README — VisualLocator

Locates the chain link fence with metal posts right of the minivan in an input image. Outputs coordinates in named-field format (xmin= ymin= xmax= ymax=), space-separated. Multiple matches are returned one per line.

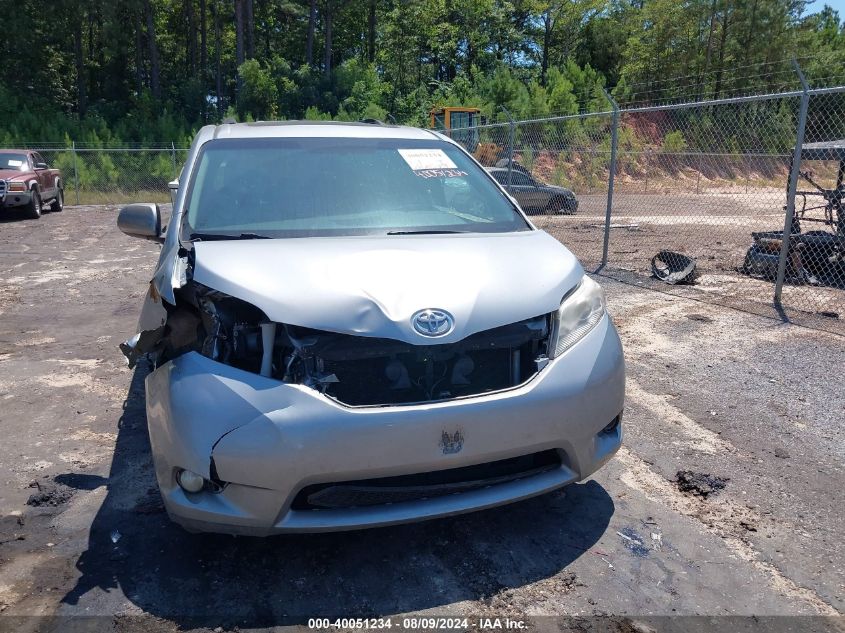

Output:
xmin=450 ymin=87 xmax=845 ymax=334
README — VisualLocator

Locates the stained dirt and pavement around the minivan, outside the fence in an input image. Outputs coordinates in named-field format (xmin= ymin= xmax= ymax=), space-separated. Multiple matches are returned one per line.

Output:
xmin=0 ymin=207 xmax=845 ymax=633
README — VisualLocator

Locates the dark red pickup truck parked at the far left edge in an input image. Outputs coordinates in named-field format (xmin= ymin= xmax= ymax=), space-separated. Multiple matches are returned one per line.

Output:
xmin=0 ymin=149 xmax=64 ymax=218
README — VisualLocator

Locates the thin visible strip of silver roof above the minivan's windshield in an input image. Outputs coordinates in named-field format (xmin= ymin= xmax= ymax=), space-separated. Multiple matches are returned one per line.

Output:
xmin=198 ymin=121 xmax=446 ymax=141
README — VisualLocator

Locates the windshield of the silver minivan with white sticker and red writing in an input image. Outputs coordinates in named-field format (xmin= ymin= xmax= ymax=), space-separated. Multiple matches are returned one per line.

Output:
xmin=182 ymin=138 xmax=530 ymax=239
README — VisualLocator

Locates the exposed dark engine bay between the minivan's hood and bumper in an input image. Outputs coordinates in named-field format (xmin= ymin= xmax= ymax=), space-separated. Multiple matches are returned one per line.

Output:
xmin=127 ymin=281 xmax=553 ymax=406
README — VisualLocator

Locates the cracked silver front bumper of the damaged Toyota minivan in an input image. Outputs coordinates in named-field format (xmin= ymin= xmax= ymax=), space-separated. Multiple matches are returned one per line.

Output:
xmin=146 ymin=317 xmax=625 ymax=535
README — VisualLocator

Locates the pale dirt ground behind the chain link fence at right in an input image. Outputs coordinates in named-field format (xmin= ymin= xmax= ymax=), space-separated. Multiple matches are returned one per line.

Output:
xmin=532 ymin=190 xmax=845 ymax=333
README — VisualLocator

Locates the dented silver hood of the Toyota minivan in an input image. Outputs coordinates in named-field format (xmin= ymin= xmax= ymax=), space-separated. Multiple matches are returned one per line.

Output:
xmin=193 ymin=231 xmax=583 ymax=344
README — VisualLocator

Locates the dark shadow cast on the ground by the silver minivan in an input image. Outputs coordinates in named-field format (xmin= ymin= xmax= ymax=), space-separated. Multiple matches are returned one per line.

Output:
xmin=62 ymin=362 xmax=614 ymax=628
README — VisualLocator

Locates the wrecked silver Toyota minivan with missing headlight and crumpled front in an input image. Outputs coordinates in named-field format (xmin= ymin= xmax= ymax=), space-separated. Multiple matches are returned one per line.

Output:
xmin=118 ymin=122 xmax=625 ymax=535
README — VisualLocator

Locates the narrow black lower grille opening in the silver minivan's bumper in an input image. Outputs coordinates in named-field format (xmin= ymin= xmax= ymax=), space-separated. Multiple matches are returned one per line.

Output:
xmin=291 ymin=450 xmax=561 ymax=510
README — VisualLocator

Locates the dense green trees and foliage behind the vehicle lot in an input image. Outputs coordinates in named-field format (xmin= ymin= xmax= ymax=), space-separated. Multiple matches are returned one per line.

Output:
xmin=0 ymin=0 xmax=845 ymax=170
